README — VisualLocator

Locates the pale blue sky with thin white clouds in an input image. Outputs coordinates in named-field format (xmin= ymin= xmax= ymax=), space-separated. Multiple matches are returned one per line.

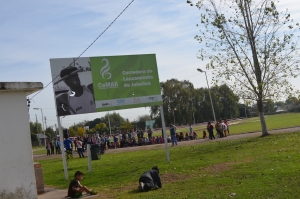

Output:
xmin=0 ymin=0 xmax=300 ymax=127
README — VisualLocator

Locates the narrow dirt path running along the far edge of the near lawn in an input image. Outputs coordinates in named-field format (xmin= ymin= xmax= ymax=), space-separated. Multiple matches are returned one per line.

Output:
xmin=33 ymin=126 xmax=300 ymax=161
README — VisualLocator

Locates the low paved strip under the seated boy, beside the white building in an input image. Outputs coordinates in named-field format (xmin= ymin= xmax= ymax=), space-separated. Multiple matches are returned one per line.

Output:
xmin=38 ymin=188 xmax=99 ymax=199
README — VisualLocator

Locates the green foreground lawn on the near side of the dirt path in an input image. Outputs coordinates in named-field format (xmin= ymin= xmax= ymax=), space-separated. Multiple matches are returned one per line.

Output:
xmin=40 ymin=132 xmax=300 ymax=199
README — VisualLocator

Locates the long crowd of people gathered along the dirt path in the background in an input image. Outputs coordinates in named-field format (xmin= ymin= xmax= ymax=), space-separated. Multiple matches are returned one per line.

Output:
xmin=46 ymin=119 xmax=229 ymax=158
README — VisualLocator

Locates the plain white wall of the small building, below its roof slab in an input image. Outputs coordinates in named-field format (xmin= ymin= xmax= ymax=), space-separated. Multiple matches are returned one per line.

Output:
xmin=0 ymin=82 xmax=41 ymax=199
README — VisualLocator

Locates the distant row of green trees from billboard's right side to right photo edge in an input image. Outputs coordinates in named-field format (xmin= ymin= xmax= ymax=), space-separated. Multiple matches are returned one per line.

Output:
xmin=150 ymin=79 xmax=300 ymax=127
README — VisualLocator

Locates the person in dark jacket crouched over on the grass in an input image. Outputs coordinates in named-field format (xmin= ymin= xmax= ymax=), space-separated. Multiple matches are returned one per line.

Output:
xmin=139 ymin=166 xmax=162 ymax=191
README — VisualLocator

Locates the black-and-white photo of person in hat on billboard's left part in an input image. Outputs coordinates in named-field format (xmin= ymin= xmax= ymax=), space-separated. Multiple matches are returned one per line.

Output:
xmin=50 ymin=57 xmax=96 ymax=116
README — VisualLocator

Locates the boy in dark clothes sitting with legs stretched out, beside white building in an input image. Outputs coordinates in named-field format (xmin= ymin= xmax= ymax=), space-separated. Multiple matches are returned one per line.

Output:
xmin=65 ymin=171 xmax=97 ymax=198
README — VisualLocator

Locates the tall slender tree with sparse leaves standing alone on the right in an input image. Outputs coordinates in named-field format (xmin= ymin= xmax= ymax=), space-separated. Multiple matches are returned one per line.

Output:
xmin=195 ymin=0 xmax=299 ymax=135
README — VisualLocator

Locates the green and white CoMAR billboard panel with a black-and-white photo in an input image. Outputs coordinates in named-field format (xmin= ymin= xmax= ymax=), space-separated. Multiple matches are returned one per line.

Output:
xmin=50 ymin=54 xmax=162 ymax=116
